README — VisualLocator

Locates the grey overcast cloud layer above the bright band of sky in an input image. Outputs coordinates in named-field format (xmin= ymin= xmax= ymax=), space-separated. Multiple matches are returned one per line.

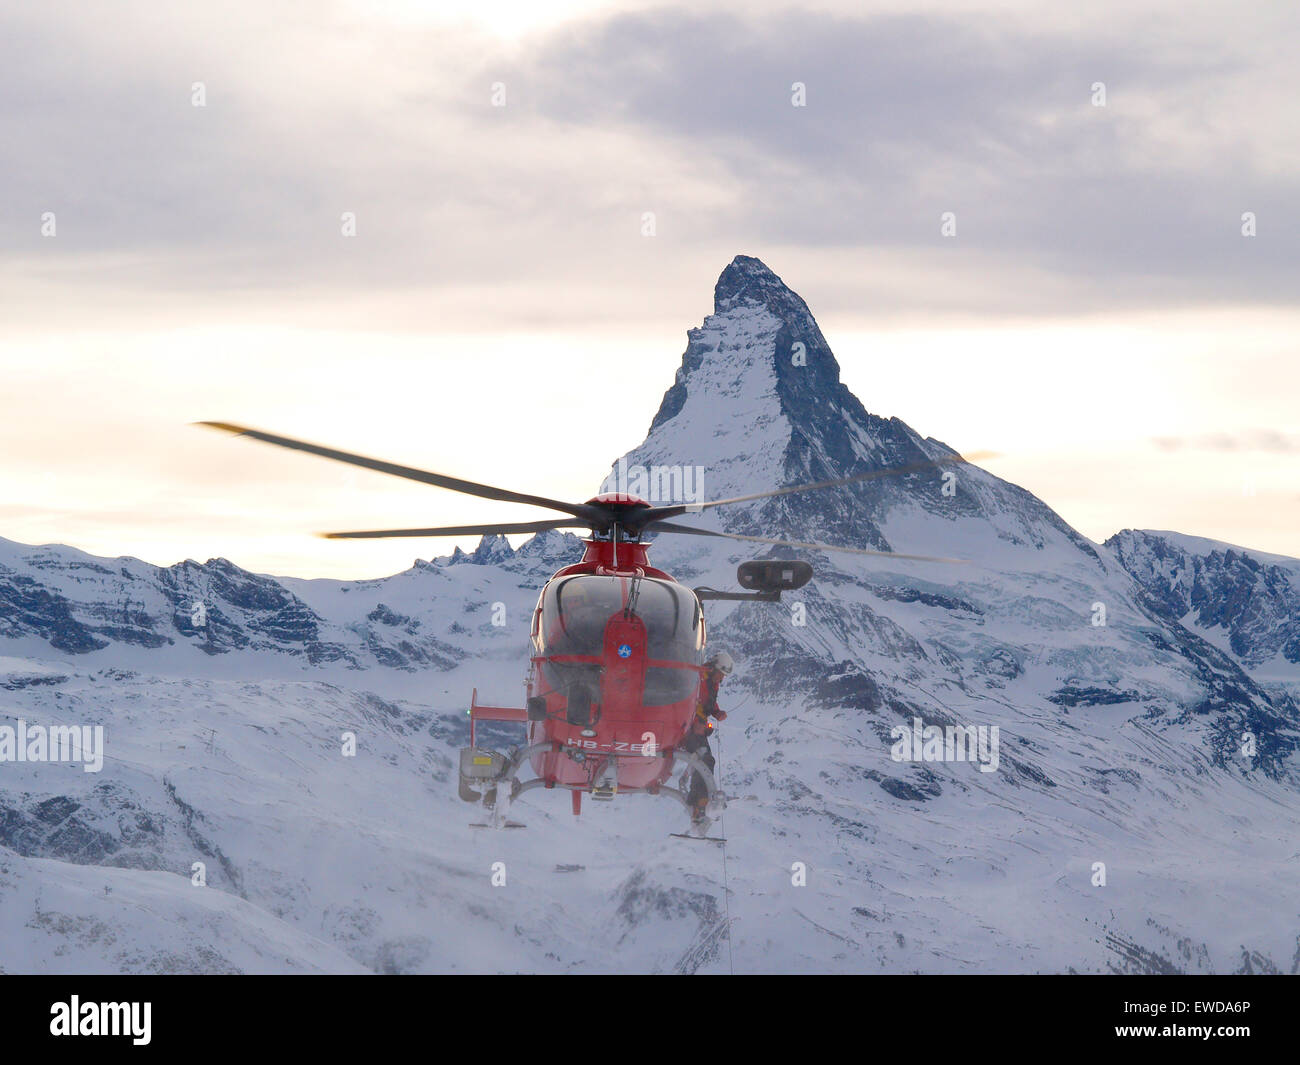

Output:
xmin=0 ymin=4 xmax=1300 ymax=325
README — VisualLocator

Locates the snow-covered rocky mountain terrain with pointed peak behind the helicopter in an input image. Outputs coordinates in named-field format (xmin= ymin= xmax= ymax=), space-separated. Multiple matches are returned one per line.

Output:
xmin=0 ymin=256 xmax=1300 ymax=971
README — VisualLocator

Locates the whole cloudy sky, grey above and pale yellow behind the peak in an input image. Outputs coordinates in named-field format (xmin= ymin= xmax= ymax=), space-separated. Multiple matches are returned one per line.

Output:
xmin=0 ymin=0 xmax=1300 ymax=576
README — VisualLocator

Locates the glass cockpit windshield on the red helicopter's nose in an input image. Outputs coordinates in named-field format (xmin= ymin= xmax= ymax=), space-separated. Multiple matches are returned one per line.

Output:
xmin=533 ymin=573 xmax=705 ymax=706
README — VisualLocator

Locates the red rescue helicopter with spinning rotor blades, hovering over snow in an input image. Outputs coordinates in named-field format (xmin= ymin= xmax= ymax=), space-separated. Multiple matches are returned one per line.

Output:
xmin=199 ymin=421 xmax=967 ymax=835
